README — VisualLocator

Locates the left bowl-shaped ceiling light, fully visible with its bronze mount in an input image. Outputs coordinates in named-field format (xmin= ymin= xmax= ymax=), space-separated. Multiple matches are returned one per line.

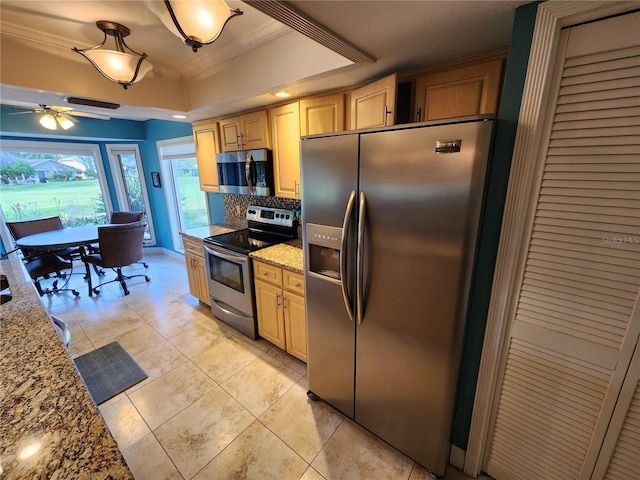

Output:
xmin=72 ymin=20 xmax=153 ymax=90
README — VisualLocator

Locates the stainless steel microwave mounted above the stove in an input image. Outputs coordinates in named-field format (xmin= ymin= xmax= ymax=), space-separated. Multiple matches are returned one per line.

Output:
xmin=216 ymin=149 xmax=274 ymax=196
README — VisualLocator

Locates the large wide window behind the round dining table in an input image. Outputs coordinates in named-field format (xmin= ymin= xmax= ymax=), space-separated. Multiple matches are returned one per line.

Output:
xmin=0 ymin=140 xmax=112 ymax=246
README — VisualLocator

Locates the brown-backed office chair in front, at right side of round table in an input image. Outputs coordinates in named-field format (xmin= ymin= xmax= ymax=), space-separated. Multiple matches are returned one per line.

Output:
xmin=83 ymin=221 xmax=151 ymax=296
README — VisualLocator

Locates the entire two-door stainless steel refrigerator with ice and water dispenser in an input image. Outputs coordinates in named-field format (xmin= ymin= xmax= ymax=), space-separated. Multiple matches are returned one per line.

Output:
xmin=300 ymin=117 xmax=493 ymax=475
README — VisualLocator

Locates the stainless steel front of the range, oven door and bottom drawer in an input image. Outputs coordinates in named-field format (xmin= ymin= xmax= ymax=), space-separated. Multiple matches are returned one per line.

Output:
xmin=204 ymin=243 xmax=257 ymax=338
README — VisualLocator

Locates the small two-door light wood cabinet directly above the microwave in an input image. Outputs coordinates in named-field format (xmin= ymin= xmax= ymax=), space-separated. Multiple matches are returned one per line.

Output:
xmin=220 ymin=110 xmax=271 ymax=152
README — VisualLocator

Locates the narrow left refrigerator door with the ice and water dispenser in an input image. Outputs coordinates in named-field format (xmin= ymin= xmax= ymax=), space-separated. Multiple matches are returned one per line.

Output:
xmin=300 ymin=134 xmax=359 ymax=418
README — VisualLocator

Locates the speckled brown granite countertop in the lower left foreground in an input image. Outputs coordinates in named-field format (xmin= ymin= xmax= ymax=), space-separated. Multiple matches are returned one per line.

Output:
xmin=0 ymin=255 xmax=133 ymax=480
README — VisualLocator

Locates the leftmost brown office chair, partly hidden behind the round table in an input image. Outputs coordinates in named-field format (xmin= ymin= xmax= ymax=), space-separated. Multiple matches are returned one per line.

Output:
xmin=6 ymin=216 xmax=80 ymax=297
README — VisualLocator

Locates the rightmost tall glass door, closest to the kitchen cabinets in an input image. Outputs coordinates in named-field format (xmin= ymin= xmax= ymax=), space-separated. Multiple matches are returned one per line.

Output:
xmin=157 ymin=136 xmax=209 ymax=251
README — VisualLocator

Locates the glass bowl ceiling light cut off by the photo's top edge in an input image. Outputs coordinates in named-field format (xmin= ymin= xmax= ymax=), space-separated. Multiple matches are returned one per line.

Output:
xmin=144 ymin=0 xmax=243 ymax=52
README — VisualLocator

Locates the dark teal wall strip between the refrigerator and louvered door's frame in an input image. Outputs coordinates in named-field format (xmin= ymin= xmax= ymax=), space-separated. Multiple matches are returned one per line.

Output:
xmin=451 ymin=2 xmax=540 ymax=450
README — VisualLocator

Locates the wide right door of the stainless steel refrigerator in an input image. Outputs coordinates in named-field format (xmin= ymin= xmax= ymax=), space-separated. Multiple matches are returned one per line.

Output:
xmin=355 ymin=122 xmax=492 ymax=475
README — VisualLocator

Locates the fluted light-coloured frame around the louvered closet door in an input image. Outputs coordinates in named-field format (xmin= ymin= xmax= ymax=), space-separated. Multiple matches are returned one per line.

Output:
xmin=464 ymin=1 xmax=638 ymax=477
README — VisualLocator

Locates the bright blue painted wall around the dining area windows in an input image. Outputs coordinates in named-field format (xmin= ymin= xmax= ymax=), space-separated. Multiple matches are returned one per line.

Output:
xmin=0 ymin=106 xmax=192 ymax=250
